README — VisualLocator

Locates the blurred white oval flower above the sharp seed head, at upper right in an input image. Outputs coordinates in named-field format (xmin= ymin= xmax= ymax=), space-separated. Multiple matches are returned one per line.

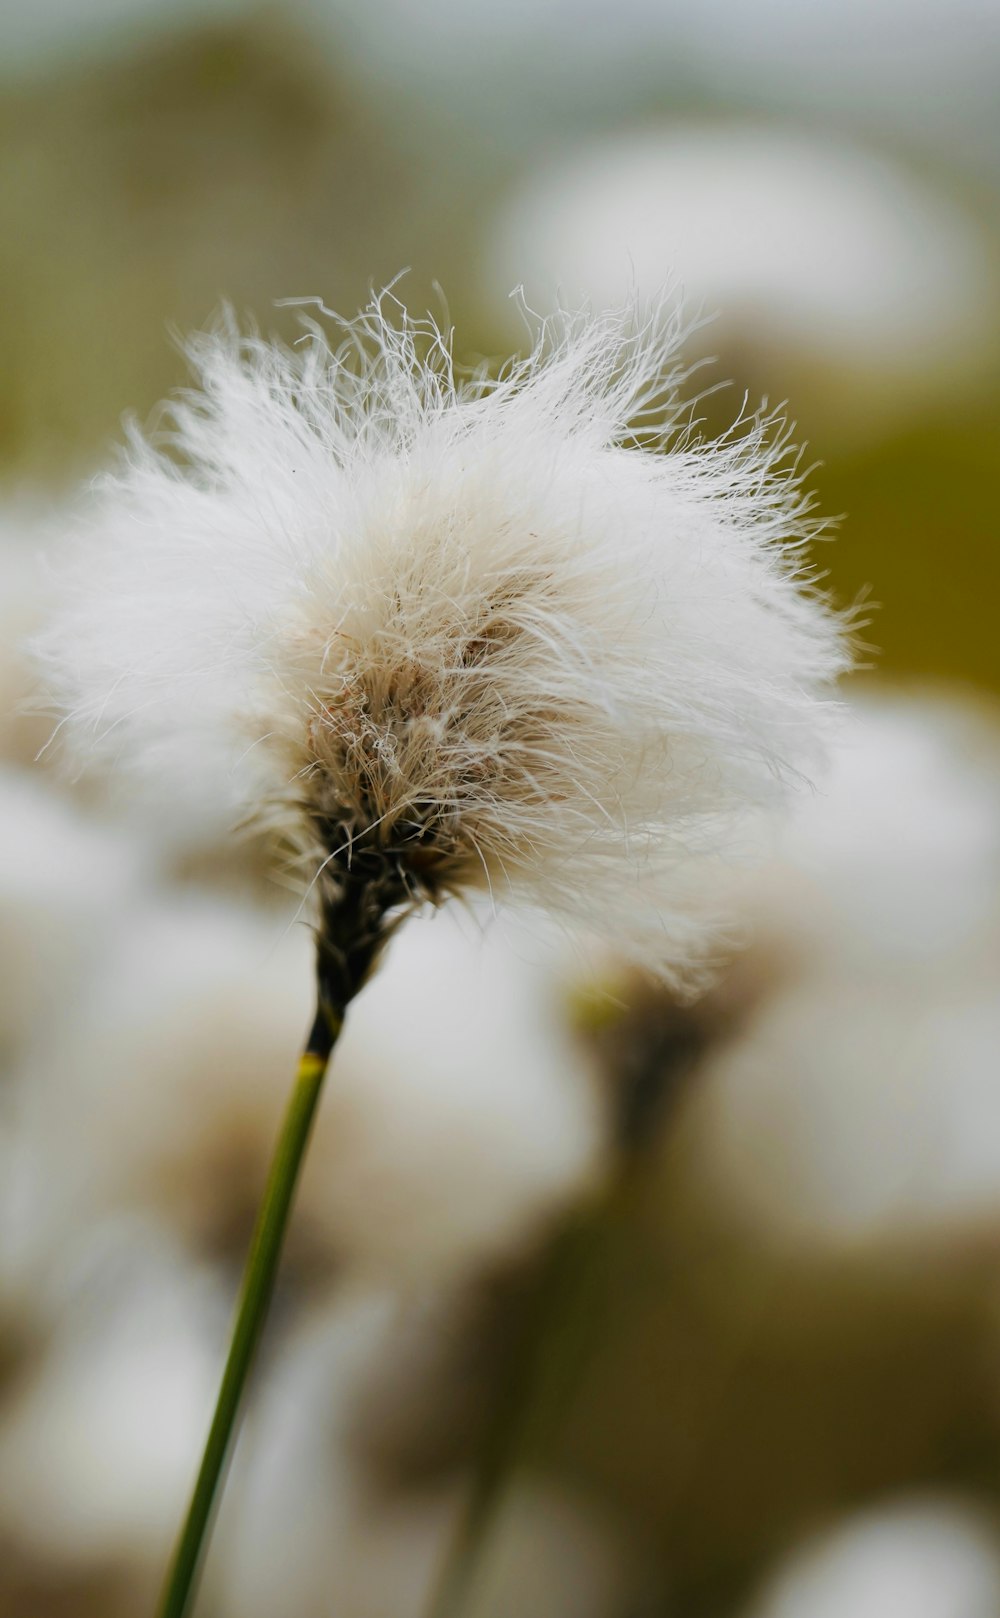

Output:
xmin=481 ymin=123 xmax=997 ymax=424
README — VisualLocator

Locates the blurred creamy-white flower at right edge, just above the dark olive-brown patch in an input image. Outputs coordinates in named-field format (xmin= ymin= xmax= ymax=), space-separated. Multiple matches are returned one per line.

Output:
xmin=688 ymin=972 xmax=1000 ymax=1246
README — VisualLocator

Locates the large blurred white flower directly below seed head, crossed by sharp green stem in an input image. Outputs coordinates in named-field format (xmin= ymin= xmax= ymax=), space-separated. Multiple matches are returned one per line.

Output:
xmin=3 ymin=893 xmax=604 ymax=1301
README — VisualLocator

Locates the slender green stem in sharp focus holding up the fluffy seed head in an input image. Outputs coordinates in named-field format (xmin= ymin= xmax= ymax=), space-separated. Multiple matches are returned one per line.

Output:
xmin=157 ymin=1010 xmax=340 ymax=1618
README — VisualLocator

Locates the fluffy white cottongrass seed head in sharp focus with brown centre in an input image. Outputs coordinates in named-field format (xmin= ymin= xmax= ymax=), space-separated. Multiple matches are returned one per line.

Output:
xmin=42 ymin=294 xmax=846 ymax=979
